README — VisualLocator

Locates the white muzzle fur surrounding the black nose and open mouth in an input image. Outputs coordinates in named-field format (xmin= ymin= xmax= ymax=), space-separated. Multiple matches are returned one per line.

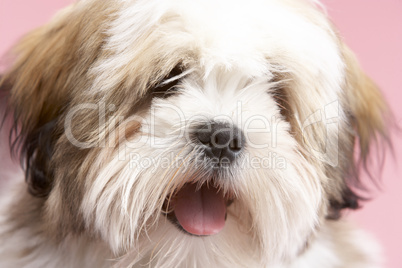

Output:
xmin=82 ymin=72 xmax=321 ymax=265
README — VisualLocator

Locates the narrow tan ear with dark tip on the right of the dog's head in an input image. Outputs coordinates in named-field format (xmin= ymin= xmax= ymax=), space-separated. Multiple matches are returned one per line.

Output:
xmin=329 ymin=44 xmax=390 ymax=218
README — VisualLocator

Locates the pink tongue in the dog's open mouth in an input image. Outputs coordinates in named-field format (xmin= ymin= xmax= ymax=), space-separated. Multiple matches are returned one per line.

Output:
xmin=174 ymin=184 xmax=226 ymax=235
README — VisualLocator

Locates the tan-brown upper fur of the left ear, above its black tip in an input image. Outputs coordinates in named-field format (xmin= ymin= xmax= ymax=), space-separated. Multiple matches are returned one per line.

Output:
xmin=4 ymin=1 xmax=118 ymax=135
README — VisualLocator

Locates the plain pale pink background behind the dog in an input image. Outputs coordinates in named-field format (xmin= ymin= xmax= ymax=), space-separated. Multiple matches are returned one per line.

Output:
xmin=0 ymin=0 xmax=402 ymax=268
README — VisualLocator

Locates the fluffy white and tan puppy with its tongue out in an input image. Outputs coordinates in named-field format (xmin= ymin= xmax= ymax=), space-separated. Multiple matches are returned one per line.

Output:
xmin=0 ymin=0 xmax=387 ymax=268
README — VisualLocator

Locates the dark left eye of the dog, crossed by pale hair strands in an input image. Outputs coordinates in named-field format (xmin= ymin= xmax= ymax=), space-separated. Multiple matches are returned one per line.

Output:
xmin=152 ymin=65 xmax=184 ymax=99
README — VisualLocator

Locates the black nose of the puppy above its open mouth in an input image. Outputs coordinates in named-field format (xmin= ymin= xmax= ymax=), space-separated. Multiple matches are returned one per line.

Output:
xmin=195 ymin=122 xmax=245 ymax=163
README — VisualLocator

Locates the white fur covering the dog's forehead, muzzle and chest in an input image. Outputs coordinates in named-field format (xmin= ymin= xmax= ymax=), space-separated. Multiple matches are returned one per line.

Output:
xmin=0 ymin=0 xmax=384 ymax=268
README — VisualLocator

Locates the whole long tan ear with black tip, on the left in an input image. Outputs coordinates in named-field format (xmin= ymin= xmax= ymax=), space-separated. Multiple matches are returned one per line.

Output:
xmin=0 ymin=3 xmax=107 ymax=196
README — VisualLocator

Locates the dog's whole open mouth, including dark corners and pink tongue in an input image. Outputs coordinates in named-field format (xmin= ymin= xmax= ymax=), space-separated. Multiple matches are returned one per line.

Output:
xmin=163 ymin=183 xmax=233 ymax=236
